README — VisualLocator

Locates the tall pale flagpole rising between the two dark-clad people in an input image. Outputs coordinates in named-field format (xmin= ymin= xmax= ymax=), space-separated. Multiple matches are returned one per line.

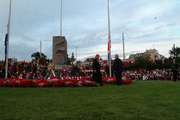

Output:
xmin=107 ymin=0 xmax=111 ymax=76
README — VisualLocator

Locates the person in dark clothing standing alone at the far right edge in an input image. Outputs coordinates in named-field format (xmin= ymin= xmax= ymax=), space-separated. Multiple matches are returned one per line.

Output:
xmin=172 ymin=59 xmax=179 ymax=82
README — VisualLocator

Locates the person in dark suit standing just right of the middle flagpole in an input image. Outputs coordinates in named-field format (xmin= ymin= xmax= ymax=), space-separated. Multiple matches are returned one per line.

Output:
xmin=113 ymin=54 xmax=122 ymax=86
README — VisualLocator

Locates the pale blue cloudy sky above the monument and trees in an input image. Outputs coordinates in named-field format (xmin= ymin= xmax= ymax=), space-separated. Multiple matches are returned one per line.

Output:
xmin=0 ymin=0 xmax=180 ymax=61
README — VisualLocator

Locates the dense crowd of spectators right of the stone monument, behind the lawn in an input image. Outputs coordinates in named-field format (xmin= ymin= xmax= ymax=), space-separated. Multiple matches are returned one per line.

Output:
xmin=84 ymin=59 xmax=180 ymax=81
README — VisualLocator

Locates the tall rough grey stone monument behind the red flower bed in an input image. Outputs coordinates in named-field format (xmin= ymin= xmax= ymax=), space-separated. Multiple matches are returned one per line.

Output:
xmin=52 ymin=36 xmax=69 ymax=77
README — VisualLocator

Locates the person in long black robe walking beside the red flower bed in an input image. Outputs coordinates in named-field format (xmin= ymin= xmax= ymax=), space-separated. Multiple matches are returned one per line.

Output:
xmin=91 ymin=54 xmax=103 ymax=86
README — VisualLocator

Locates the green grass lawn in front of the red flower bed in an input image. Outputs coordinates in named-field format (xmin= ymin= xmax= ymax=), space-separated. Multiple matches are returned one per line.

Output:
xmin=0 ymin=81 xmax=180 ymax=120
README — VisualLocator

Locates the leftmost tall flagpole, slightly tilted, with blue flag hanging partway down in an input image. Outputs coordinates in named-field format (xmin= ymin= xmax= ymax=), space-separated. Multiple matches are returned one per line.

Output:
xmin=5 ymin=0 xmax=12 ymax=78
